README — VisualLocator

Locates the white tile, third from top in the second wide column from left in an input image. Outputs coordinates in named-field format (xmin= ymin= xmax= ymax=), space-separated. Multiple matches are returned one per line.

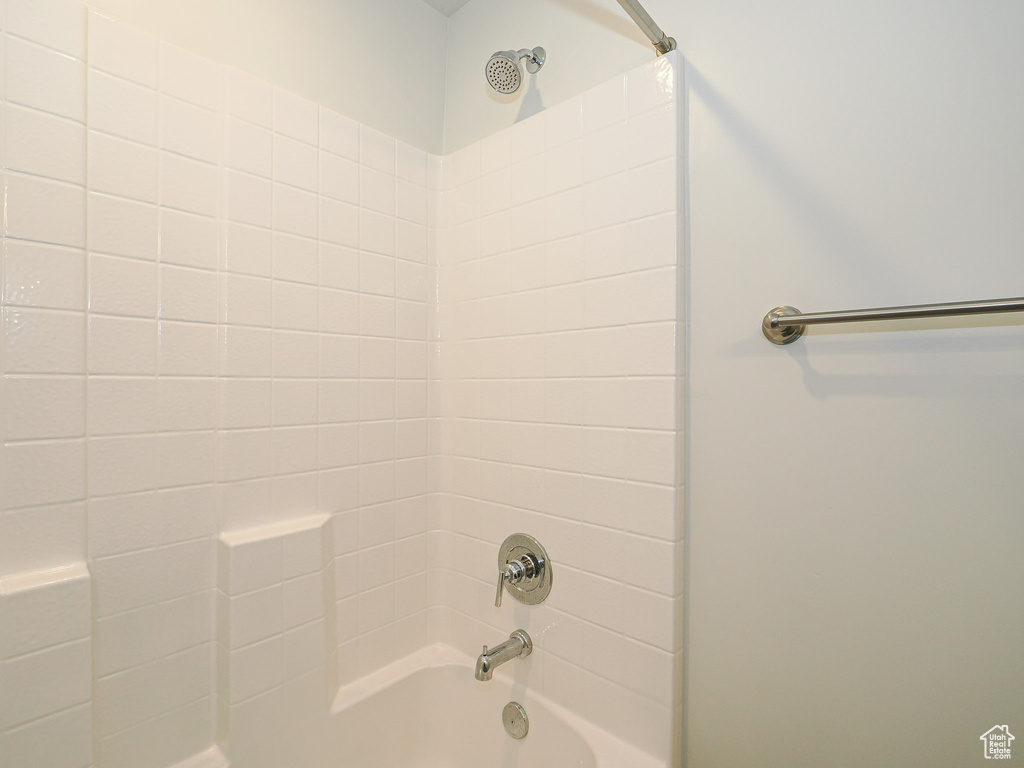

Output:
xmin=89 ymin=132 xmax=160 ymax=203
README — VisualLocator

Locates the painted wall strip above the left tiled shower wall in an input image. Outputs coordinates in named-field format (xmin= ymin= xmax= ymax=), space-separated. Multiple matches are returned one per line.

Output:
xmin=89 ymin=0 xmax=447 ymax=153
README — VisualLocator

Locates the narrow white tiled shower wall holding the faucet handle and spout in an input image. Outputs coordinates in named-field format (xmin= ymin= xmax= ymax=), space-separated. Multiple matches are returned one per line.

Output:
xmin=430 ymin=54 xmax=684 ymax=760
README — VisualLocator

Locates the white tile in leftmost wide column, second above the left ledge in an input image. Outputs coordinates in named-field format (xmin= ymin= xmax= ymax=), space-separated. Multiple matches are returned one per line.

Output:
xmin=3 ymin=440 xmax=85 ymax=509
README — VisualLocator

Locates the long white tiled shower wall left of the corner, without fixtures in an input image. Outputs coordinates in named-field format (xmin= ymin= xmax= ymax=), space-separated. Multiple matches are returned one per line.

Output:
xmin=0 ymin=0 xmax=428 ymax=768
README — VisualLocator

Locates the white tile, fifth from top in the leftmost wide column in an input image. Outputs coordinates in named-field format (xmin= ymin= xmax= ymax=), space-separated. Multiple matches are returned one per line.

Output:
xmin=3 ymin=240 xmax=85 ymax=309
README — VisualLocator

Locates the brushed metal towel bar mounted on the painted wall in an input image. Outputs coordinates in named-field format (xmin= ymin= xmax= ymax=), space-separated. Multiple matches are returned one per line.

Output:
xmin=761 ymin=298 xmax=1024 ymax=344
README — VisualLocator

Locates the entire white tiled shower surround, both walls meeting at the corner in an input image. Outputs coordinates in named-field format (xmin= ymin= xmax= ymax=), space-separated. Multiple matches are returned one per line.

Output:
xmin=0 ymin=0 xmax=682 ymax=768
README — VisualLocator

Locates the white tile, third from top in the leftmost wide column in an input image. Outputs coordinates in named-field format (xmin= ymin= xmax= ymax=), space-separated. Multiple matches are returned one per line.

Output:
xmin=6 ymin=104 xmax=85 ymax=184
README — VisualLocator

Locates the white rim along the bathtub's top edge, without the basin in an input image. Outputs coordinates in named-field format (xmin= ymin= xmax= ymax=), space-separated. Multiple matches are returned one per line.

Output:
xmin=331 ymin=643 xmax=668 ymax=768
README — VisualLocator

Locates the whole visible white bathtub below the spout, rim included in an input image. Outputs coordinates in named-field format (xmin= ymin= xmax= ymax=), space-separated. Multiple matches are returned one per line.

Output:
xmin=328 ymin=645 xmax=665 ymax=768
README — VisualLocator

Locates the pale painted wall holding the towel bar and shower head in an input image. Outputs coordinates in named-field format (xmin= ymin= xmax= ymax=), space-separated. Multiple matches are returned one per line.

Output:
xmin=445 ymin=0 xmax=1024 ymax=768
